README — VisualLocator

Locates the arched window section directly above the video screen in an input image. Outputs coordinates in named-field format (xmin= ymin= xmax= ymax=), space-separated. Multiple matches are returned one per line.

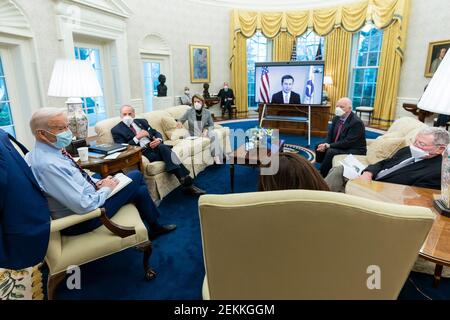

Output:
xmin=296 ymin=30 xmax=325 ymax=61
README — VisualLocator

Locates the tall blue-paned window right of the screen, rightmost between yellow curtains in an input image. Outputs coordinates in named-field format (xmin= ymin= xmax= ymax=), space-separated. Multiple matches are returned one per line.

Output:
xmin=350 ymin=25 xmax=383 ymax=107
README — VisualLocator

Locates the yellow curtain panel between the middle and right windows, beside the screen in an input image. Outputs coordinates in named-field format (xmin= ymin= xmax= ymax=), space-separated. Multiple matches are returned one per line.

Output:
xmin=325 ymin=28 xmax=352 ymax=113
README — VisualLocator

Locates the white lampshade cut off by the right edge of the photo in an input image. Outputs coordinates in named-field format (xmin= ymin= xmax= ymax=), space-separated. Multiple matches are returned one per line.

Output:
xmin=417 ymin=54 xmax=450 ymax=114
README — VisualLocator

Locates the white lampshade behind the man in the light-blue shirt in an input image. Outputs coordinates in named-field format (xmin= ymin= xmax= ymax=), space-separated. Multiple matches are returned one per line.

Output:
xmin=48 ymin=60 xmax=103 ymax=98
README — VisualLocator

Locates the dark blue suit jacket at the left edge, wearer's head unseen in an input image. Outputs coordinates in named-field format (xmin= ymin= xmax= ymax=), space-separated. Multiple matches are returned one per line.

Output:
xmin=0 ymin=129 xmax=50 ymax=270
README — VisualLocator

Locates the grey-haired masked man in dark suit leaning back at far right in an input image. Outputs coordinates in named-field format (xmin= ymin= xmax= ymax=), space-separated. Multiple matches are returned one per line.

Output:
xmin=325 ymin=128 xmax=450 ymax=192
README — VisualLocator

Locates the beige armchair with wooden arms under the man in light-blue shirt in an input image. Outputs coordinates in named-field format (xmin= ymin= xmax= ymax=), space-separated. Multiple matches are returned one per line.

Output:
xmin=45 ymin=204 xmax=156 ymax=300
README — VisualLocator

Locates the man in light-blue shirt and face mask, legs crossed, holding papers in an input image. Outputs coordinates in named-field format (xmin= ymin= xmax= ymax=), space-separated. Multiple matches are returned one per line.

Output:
xmin=25 ymin=108 xmax=176 ymax=239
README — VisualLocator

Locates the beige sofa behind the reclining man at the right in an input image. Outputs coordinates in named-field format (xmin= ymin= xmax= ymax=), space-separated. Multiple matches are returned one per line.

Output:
xmin=333 ymin=117 xmax=427 ymax=167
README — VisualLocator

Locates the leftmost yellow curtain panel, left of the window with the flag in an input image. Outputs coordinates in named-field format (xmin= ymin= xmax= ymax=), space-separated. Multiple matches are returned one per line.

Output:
xmin=231 ymin=33 xmax=248 ymax=118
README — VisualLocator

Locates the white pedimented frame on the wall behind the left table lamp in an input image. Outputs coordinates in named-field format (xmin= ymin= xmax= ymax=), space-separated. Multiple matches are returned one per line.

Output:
xmin=55 ymin=0 xmax=132 ymax=120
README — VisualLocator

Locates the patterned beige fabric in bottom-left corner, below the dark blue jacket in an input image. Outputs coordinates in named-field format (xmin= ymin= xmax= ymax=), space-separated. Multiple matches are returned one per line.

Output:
xmin=0 ymin=266 xmax=44 ymax=300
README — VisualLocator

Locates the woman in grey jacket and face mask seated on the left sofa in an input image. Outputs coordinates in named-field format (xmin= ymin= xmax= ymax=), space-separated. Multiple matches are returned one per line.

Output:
xmin=177 ymin=94 xmax=223 ymax=164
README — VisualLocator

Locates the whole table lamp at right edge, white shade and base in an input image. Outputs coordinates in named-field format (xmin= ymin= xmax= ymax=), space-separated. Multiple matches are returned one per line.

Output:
xmin=417 ymin=54 xmax=450 ymax=216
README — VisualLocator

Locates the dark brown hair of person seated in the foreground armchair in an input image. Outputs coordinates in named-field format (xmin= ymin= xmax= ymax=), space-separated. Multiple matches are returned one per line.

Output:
xmin=259 ymin=153 xmax=330 ymax=191
